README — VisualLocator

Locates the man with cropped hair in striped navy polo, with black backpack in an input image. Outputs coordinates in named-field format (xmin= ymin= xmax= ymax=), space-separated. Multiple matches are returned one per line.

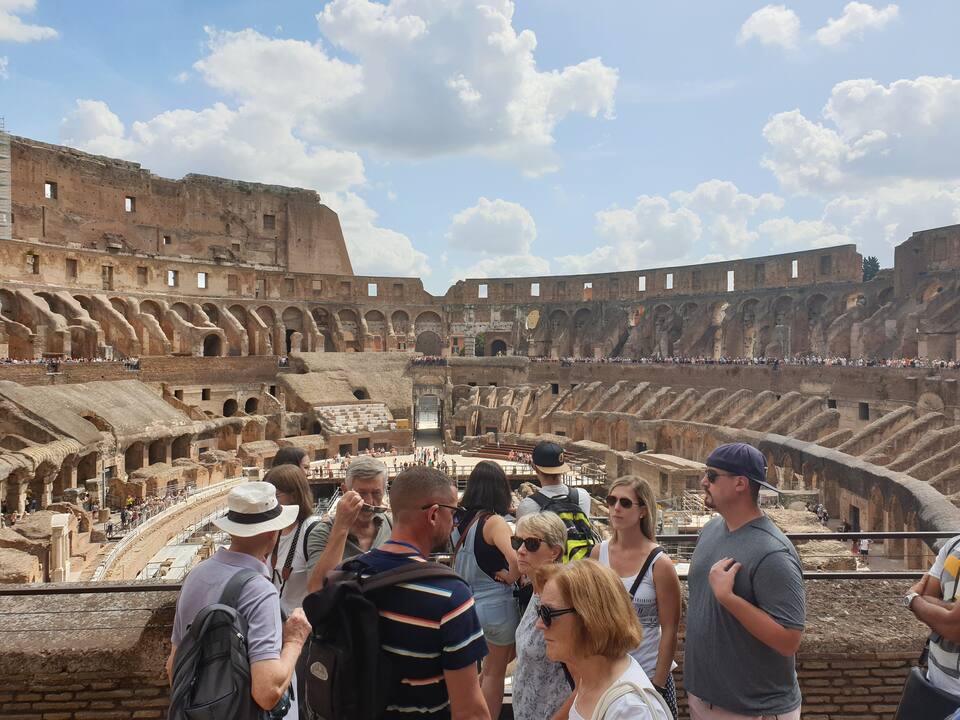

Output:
xmin=304 ymin=466 xmax=489 ymax=720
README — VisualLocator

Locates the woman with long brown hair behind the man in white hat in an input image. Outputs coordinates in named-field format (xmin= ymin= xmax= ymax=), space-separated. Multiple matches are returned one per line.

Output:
xmin=263 ymin=465 xmax=319 ymax=615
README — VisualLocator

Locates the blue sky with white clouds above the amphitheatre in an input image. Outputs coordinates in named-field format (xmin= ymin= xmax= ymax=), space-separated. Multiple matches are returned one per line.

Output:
xmin=0 ymin=0 xmax=960 ymax=294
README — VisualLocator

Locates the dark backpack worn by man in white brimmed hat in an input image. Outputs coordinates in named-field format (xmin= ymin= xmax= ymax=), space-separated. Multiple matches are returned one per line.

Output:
xmin=167 ymin=569 xmax=268 ymax=720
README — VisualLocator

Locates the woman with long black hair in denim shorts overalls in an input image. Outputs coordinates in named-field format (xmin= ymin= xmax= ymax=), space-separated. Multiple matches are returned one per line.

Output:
xmin=453 ymin=460 xmax=520 ymax=718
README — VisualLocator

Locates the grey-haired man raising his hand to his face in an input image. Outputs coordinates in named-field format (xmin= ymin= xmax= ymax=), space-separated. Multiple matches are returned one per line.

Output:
xmin=306 ymin=455 xmax=392 ymax=592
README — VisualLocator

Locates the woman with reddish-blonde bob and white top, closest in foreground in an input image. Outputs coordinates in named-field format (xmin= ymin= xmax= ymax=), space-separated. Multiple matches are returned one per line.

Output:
xmin=535 ymin=560 xmax=671 ymax=720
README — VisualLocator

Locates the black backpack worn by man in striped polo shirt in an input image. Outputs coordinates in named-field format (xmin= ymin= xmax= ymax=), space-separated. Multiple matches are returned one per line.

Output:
xmin=300 ymin=559 xmax=460 ymax=720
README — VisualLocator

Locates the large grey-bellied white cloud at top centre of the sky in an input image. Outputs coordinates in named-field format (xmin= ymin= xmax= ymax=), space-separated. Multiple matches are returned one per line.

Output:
xmin=313 ymin=0 xmax=618 ymax=175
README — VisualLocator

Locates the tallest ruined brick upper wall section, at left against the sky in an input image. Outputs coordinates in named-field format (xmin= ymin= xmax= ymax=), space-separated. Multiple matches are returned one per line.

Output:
xmin=10 ymin=137 xmax=353 ymax=275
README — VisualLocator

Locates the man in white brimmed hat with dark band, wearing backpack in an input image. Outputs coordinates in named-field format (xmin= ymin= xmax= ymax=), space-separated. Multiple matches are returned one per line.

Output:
xmin=167 ymin=482 xmax=310 ymax=720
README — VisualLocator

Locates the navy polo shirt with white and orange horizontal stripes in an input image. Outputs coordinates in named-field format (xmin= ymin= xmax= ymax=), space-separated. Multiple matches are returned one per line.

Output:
xmin=354 ymin=550 xmax=487 ymax=720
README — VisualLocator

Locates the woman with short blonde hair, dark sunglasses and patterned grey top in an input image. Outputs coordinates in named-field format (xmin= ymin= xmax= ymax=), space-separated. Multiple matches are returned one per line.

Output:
xmin=511 ymin=512 xmax=572 ymax=720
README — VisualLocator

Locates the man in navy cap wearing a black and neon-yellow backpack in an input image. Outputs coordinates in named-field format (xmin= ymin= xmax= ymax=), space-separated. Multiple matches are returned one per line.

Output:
xmin=517 ymin=441 xmax=600 ymax=562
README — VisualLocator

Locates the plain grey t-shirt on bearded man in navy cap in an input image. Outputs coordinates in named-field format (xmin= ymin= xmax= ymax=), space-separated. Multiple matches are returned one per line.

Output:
xmin=683 ymin=515 xmax=806 ymax=716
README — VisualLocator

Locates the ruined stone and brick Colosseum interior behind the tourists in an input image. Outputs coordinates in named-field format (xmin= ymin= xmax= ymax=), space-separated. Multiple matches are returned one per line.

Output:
xmin=0 ymin=135 xmax=960 ymax=720
